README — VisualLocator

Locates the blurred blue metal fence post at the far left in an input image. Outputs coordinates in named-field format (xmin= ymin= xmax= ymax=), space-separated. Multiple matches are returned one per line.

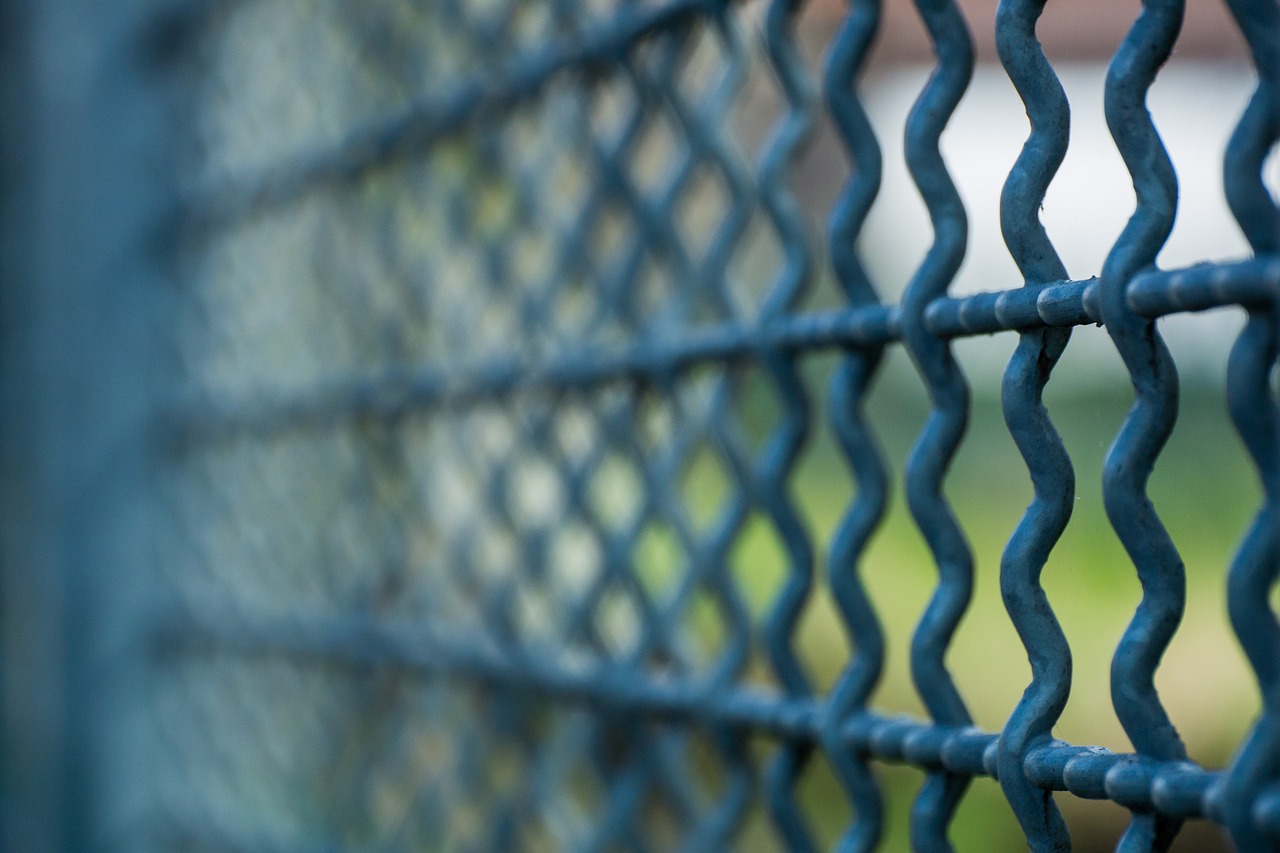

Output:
xmin=0 ymin=0 xmax=172 ymax=853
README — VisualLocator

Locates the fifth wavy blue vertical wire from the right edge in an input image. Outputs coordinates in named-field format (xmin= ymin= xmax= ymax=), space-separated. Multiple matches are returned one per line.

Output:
xmin=823 ymin=0 xmax=888 ymax=853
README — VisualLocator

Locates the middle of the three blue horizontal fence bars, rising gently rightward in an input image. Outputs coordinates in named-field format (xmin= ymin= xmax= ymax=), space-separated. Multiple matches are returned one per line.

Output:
xmin=172 ymin=259 xmax=1280 ymax=447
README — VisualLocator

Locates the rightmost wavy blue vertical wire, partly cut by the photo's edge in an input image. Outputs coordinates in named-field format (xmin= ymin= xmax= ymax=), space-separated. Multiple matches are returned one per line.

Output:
xmin=1219 ymin=0 xmax=1280 ymax=853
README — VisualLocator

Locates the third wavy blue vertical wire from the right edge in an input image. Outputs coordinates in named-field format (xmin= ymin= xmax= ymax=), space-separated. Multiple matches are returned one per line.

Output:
xmin=996 ymin=0 xmax=1075 ymax=853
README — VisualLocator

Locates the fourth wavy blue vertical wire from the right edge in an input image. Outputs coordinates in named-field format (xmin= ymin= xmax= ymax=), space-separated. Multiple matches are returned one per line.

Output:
xmin=902 ymin=0 xmax=973 ymax=853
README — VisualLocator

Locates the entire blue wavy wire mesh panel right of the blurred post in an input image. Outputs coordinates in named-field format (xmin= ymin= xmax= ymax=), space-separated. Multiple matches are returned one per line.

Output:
xmin=146 ymin=0 xmax=1280 ymax=850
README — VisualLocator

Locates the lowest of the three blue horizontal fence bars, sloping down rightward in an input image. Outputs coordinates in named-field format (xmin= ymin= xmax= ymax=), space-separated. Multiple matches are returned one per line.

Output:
xmin=152 ymin=601 xmax=1249 ymax=824
